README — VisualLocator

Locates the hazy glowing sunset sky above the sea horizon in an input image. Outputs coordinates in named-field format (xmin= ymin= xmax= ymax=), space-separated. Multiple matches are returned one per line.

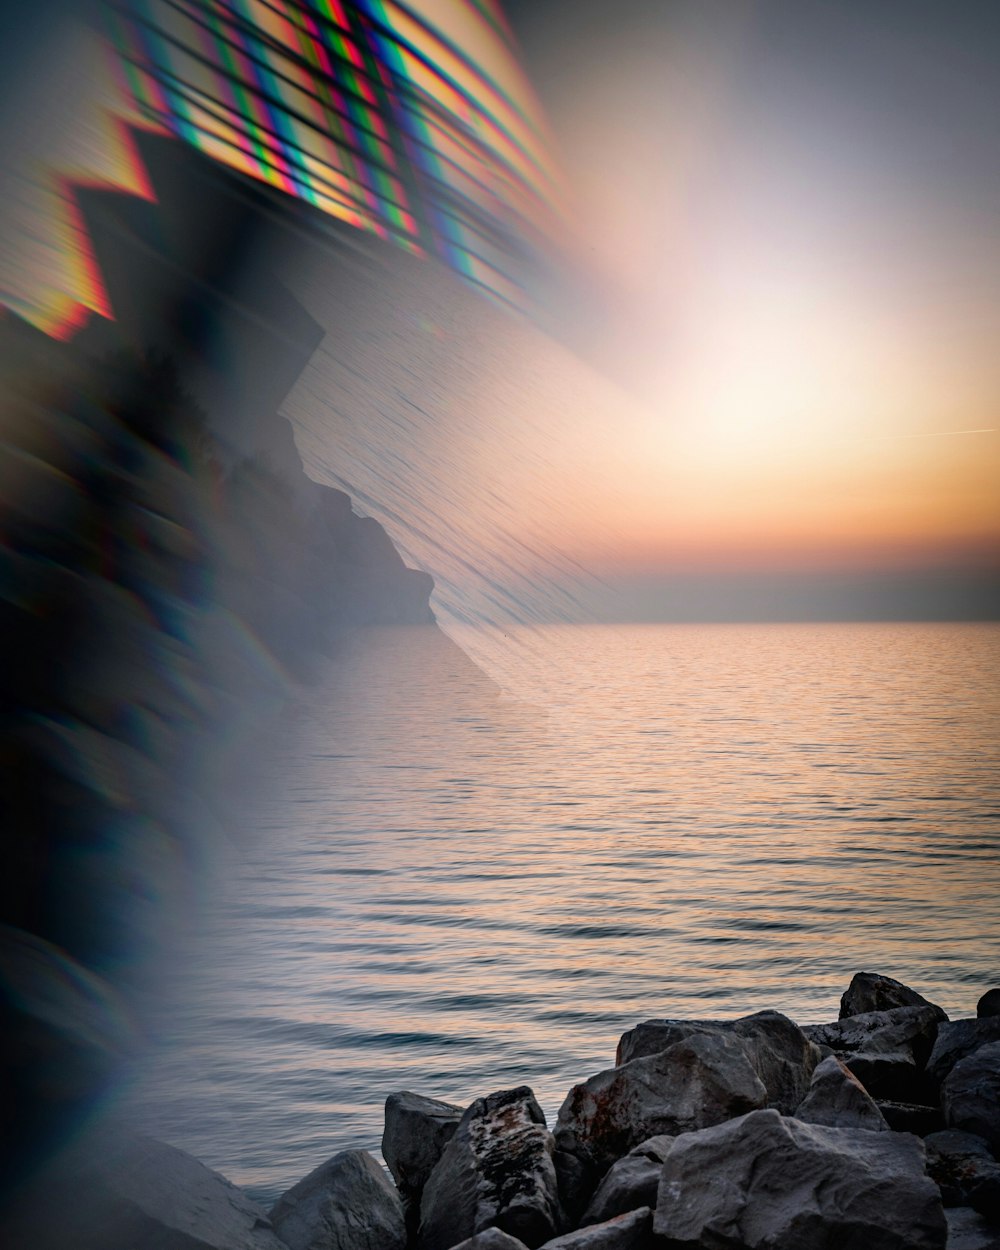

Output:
xmin=0 ymin=0 xmax=1000 ymax=624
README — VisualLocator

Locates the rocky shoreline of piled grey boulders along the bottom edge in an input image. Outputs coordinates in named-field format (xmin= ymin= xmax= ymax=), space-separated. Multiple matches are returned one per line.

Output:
xmin=8 ymin=973 xmax=1000 ymax=1250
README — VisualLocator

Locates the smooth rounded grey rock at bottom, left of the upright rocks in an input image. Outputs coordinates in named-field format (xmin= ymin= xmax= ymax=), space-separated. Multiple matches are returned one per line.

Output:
xmin=271 ymin=1150 xmax=406 ymax=1250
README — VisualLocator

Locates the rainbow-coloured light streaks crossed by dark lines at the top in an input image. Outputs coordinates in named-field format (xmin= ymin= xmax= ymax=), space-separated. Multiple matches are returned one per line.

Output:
xmin=109 ymin=0 xmax=558 ymax=306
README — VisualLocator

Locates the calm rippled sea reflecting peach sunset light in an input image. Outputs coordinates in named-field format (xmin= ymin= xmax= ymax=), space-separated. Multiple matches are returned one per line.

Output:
xmin=125 ymin=624 xmax=1000 ymax=1199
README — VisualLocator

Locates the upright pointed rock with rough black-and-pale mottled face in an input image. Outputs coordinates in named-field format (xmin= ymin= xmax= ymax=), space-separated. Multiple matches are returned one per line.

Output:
xmin=418 ymin=1085 xmax=563 ymax=1250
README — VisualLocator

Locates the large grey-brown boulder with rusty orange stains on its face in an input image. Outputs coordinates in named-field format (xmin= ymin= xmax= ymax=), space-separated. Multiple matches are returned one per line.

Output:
xmin=555 ymin=1033 xmax=768 ymax=1215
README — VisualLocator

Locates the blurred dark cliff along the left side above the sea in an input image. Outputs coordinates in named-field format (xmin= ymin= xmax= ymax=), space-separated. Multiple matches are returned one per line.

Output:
xmin=0 ymin=136 xmax=434 ymax=1195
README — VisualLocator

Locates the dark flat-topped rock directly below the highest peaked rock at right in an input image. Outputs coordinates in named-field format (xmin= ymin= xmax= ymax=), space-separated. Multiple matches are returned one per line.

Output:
xmin=803 ymin=1006 xmax=946 ymax=1103
